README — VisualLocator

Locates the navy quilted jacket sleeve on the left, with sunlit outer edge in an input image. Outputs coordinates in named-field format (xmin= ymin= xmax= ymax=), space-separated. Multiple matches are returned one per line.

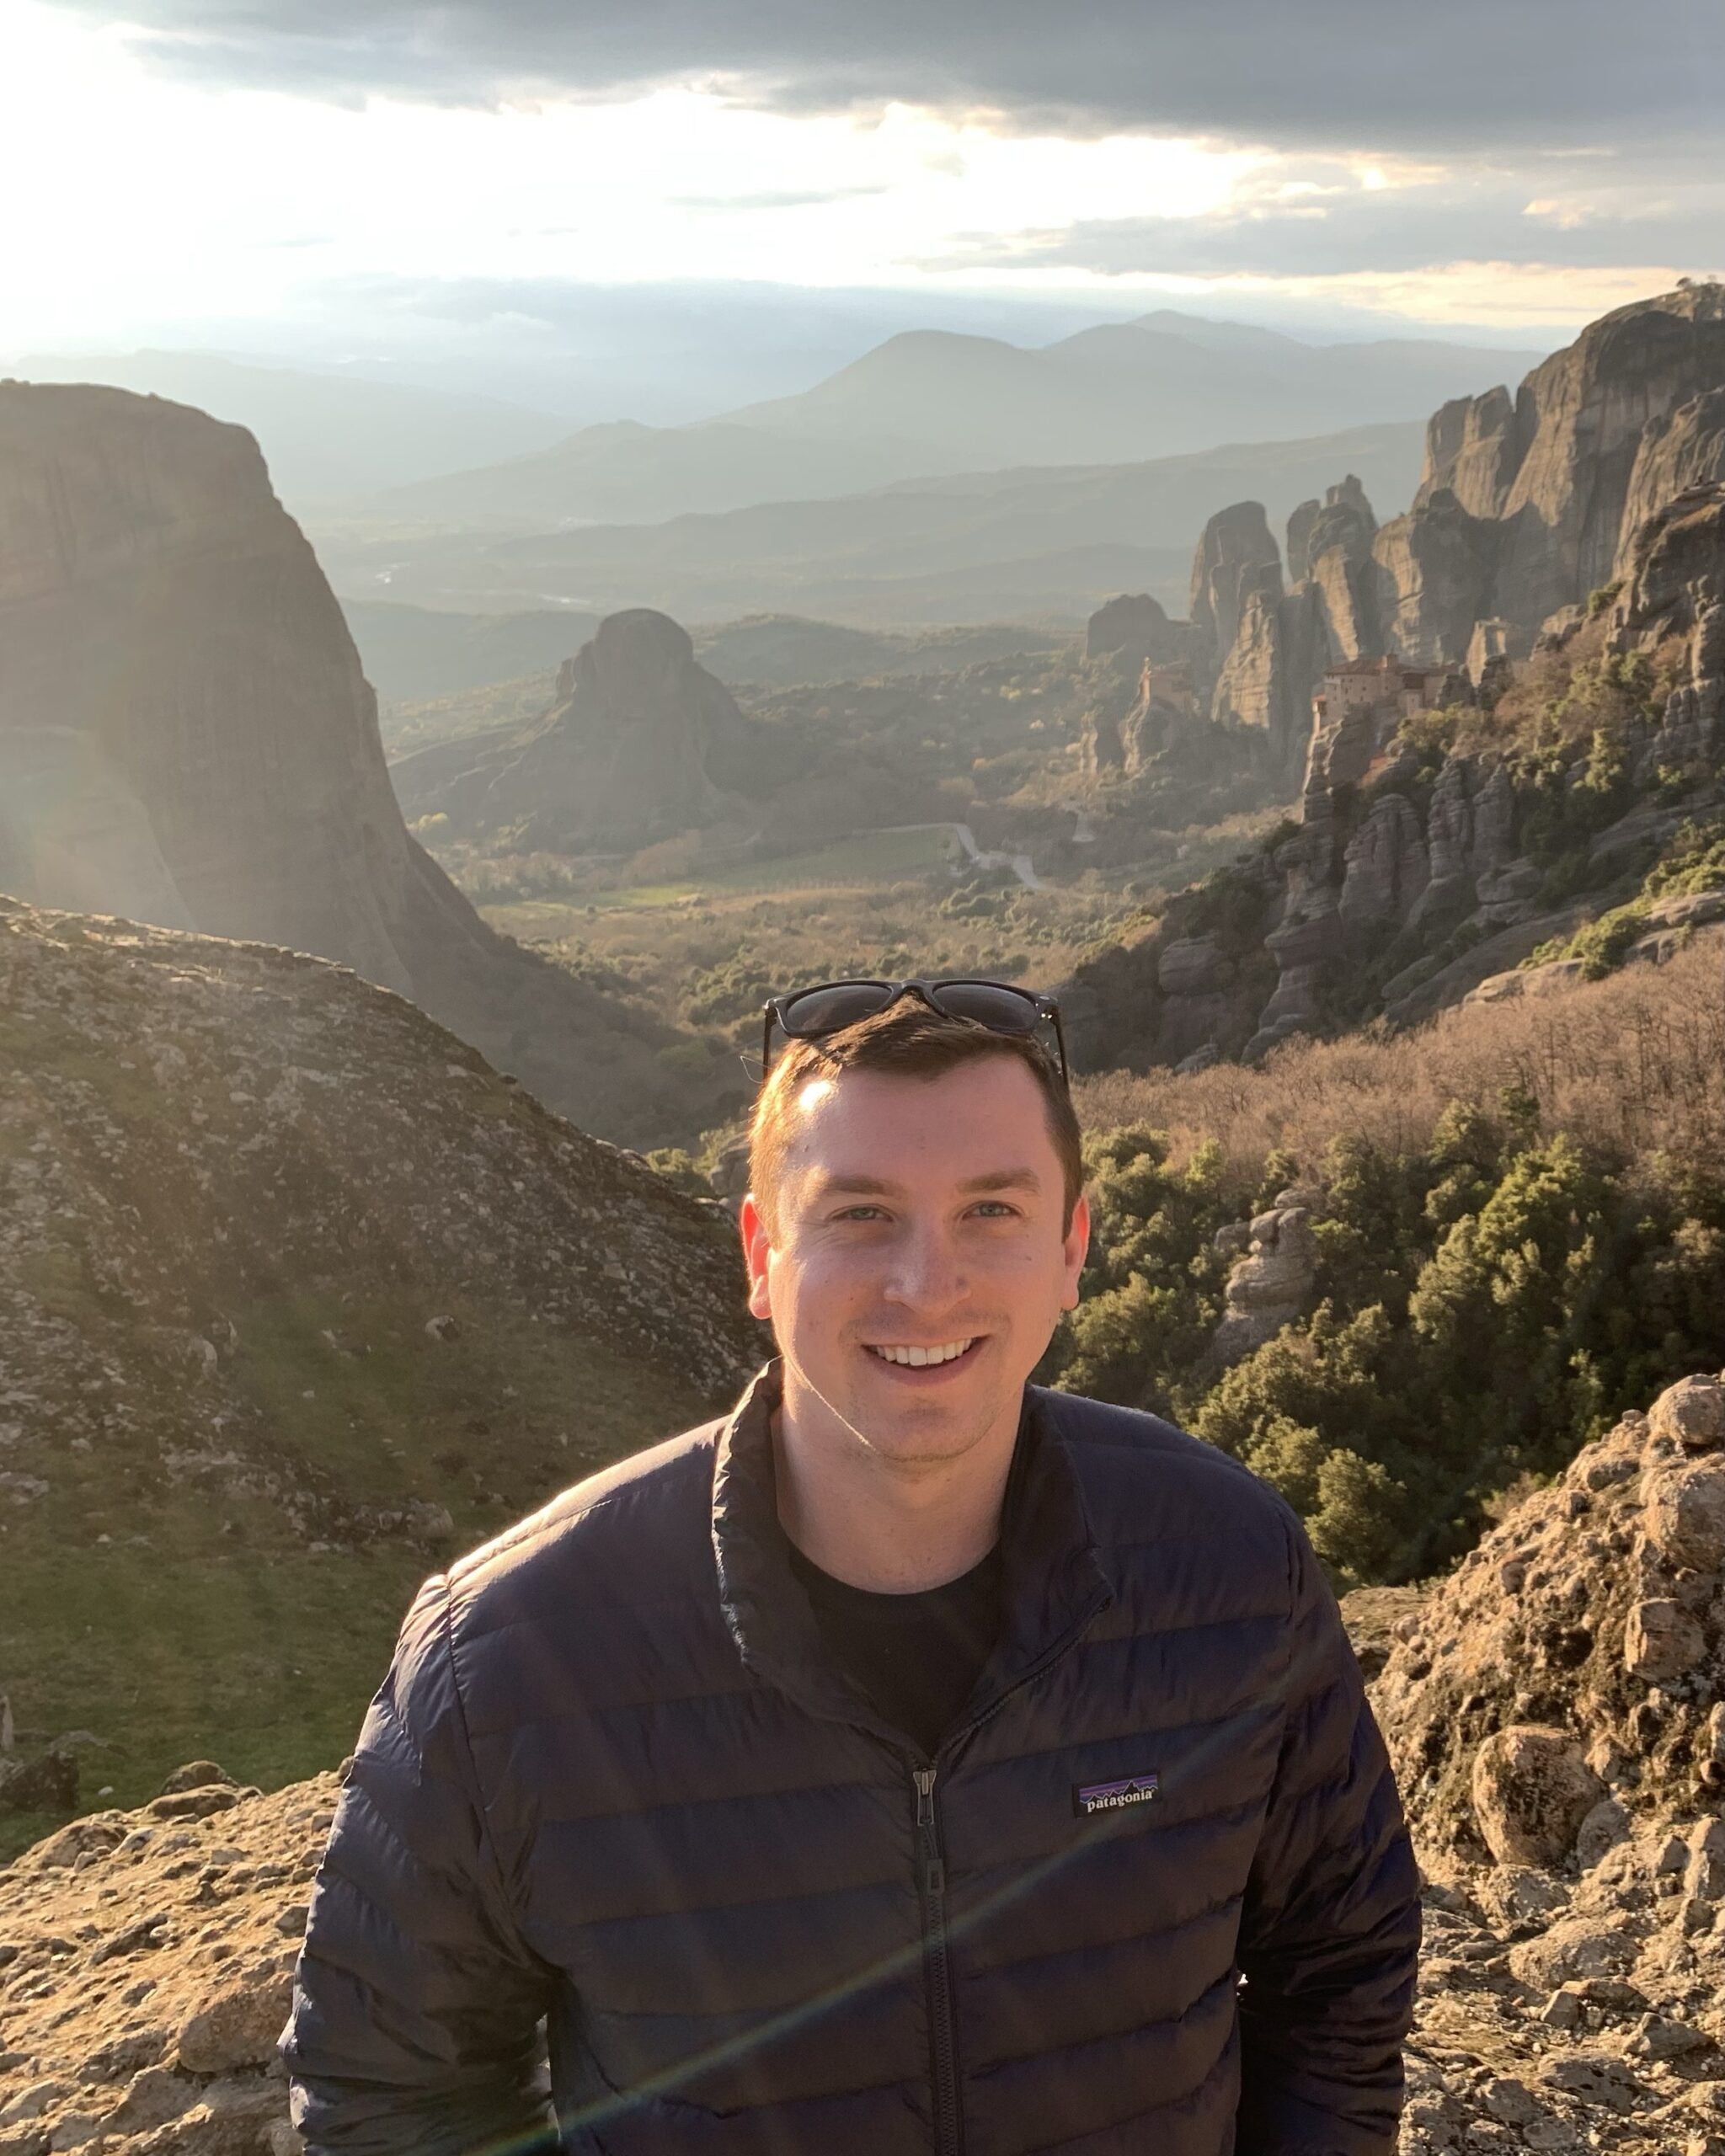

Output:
xmin=280 ymin=1578 xmax=552 ymax=2156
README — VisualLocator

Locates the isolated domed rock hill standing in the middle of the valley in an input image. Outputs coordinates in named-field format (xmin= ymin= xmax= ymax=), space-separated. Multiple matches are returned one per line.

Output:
xmin=394 ymin=606 xmax=767 ymax=854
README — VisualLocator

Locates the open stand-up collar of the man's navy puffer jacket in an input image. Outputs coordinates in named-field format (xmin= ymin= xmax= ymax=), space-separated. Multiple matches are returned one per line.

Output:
xmin=713 ymin=1360 xmax=1113 ymax=1751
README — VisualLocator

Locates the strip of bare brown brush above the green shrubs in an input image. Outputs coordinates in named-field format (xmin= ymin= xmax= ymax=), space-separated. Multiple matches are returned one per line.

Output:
xmin=1078 ymin=933 xmax=1725 ymax=1186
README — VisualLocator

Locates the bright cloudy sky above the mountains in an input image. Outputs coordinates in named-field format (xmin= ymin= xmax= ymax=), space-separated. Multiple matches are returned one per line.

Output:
xmin=0 ymin=0 xmax=1725 ymax=375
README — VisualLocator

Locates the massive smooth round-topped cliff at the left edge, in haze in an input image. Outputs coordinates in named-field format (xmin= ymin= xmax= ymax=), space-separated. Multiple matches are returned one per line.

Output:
xmin=0 ymin=382 xmax=423 ymax=994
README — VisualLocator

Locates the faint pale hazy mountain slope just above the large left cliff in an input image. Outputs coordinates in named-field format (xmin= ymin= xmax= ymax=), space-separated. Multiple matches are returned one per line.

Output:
xmin=0 ymin=351 xmax=567 ymax=513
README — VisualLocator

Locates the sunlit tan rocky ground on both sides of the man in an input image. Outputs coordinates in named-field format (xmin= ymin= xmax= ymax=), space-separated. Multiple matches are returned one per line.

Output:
xmin=0 ymin=1375 xmax=1725 ymax=2156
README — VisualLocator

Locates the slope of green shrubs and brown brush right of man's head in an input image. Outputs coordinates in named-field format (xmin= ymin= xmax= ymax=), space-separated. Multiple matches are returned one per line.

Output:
xmin=1046 ymin=951 xmax=1725 ymax=1585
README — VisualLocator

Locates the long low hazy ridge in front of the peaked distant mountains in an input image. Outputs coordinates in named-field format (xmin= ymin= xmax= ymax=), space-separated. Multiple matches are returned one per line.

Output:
xmin=312 ymin=420 xmax=1423 ymax=630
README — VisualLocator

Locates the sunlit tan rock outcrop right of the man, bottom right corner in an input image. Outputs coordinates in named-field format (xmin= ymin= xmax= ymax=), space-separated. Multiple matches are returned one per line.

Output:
xmin=1374 ymin=1375 xmax=1725 ymax=2156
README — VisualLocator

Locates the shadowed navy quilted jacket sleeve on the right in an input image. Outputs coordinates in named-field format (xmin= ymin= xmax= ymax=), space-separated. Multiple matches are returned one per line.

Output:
xmin=1236 ymin=1522 xmax=1418 ymax=2156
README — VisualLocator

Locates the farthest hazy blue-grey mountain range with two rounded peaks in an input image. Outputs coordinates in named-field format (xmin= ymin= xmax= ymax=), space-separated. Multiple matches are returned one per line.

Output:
xmin=366 ymin=311 xmax=1540 ymax=528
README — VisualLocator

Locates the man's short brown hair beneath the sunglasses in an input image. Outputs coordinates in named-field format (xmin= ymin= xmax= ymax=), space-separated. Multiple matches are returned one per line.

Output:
xmin=748 ymin=996 xmax=1085 ymax=1231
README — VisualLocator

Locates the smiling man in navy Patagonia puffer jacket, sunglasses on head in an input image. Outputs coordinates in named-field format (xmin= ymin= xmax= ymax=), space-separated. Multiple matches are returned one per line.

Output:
xmin=285 ymin=983 xmax=1418 ymax=2156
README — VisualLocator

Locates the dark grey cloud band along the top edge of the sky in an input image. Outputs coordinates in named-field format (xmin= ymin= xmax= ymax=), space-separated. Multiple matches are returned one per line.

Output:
xmin=34 ymin=0 xmax=1725 ymax=151
